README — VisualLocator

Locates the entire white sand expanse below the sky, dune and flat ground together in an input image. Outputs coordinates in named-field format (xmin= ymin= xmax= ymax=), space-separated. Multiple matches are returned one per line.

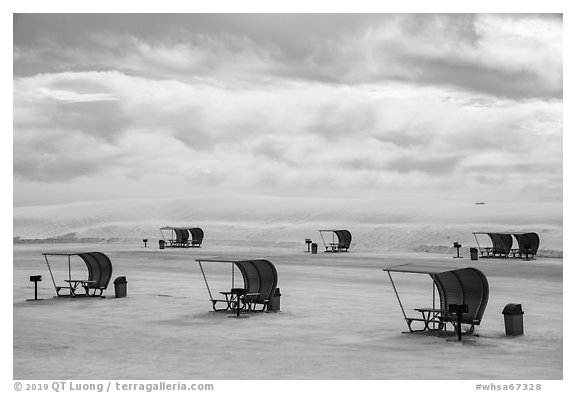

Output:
xmin=13 ymin=195 xmax=563 ymax=380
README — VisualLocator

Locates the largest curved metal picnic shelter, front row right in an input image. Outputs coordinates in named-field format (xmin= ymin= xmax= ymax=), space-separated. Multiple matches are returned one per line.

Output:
xmin=383 ymin=264 xmax=490 ymax=332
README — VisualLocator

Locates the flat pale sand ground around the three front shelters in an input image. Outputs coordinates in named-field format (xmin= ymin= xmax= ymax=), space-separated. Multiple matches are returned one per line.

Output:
xmin=13 ymin=244 xmax=563 ymax=380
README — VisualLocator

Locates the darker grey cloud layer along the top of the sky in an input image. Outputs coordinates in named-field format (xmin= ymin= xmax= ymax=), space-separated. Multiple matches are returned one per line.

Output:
xmin=14 ymin=14 xmax=563 ymax=98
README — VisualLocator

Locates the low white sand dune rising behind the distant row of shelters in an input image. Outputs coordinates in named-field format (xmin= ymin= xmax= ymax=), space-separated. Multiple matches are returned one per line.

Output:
xmin=14 ymin=195 xmax=563 ymax=256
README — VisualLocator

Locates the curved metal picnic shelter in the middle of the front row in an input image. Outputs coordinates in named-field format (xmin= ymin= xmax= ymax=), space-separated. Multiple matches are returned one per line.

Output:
xmin=196 ymin=258 xmax=278 ymax=311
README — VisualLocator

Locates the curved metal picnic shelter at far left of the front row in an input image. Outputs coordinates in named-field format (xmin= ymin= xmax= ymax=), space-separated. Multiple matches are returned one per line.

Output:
xmin=42 ymin=252 xmax=112 ymax=296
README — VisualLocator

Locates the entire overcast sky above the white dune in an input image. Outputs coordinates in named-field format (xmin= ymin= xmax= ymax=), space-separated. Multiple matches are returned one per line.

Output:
xmin=13 ymin=14 xmax=563 ymax=206
